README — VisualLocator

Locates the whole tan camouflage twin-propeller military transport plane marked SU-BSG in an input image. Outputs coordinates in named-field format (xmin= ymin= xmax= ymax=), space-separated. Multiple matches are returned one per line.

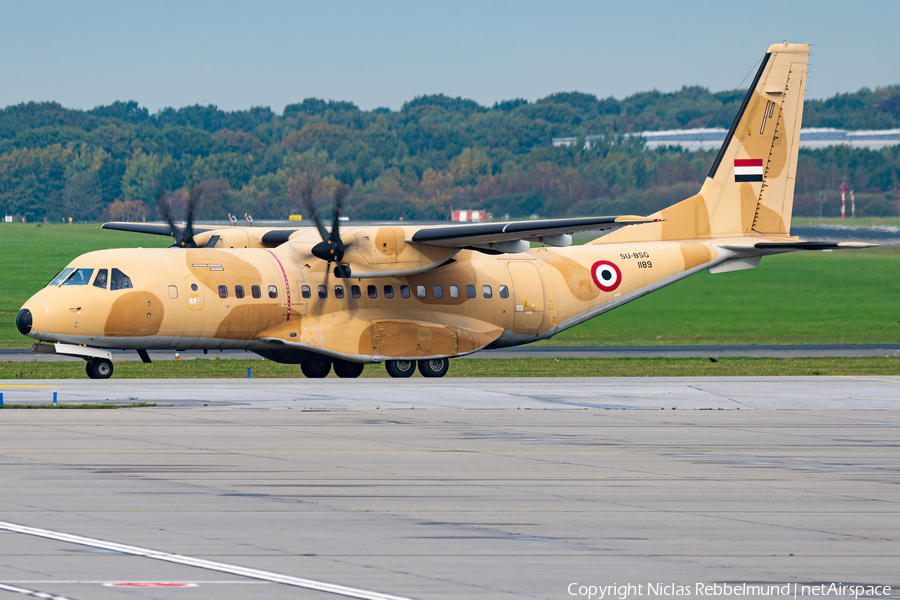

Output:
xmin=16 ymin=43 xmax=865 ymax=379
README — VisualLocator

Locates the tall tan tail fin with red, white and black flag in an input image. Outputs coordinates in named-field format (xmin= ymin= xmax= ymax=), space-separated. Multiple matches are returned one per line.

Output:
xmin=596 ymin=43 xmax=809 ymax=243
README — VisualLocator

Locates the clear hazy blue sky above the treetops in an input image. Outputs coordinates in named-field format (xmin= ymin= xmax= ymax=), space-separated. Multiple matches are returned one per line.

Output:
xmin=0 ymin=0 xmax=900 ymax=112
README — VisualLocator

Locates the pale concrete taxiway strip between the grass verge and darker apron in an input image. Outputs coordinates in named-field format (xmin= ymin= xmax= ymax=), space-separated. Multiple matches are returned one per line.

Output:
xmin=0 ymin=376 xmax=900 ymax=410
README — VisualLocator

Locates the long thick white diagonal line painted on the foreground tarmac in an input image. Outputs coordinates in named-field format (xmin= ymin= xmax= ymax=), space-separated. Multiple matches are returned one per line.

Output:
xmin=0 ymin=521 xmax=410 ymax=600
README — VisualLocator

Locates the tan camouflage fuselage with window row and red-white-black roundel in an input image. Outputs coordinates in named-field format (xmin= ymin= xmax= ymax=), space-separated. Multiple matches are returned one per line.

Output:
xmin=17 ymin=232 xmax=729 ymax=363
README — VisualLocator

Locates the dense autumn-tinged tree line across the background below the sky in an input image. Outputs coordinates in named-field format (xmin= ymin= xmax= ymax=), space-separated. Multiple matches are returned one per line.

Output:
xmin=0 ymin=85 xmax=900 ymax=221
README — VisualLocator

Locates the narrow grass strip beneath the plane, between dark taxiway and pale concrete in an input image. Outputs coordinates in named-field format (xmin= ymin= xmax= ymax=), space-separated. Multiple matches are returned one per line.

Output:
xmin=0 ymin=356 xmax=900 ymax=380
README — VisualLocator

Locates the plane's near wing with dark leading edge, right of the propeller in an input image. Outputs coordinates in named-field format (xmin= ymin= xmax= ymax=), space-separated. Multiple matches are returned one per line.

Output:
xmin=407 ymin=216 xmax=659 ymax=252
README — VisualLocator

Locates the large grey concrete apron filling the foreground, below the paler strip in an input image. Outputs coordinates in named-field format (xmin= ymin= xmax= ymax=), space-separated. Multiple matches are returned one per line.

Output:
xmin=0 ymin=404 xmax=900 ymax=600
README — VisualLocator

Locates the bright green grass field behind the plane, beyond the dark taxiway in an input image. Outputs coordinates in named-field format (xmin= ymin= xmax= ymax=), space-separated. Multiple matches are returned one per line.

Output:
xmin=0 ymin=224 xmax=900 ymax=348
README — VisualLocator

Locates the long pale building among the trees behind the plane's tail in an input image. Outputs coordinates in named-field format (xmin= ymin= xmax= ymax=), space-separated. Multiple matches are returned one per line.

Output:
xmin=553 ymin=127 xmax=900 ymax=151
